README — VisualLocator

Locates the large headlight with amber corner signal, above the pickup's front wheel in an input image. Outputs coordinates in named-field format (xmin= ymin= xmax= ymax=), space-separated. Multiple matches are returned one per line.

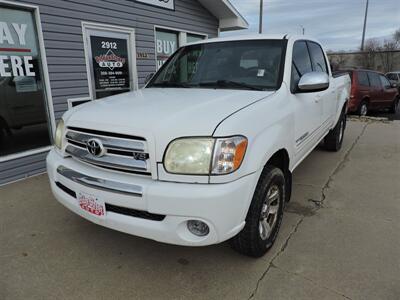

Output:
xmin=164 ymin=136 xmax=247 ymax=175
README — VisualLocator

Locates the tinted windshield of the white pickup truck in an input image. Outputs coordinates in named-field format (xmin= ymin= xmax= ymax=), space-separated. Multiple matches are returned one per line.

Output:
xmin=147 ymin=40 xmax=286 ymax=90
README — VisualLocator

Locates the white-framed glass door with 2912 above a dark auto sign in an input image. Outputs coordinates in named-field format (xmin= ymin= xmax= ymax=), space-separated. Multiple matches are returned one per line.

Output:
xmin=84 ymin=24 xmax=136 ymax=99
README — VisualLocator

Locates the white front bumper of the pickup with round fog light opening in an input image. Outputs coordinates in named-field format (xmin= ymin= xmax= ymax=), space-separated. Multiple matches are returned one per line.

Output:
xmin=47 ymin=150 xmax=259 ymax=246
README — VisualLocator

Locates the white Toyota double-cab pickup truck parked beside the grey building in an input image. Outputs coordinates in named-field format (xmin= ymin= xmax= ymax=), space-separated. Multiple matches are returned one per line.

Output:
xmin=47 ymin=35 xmax=350 ymax=257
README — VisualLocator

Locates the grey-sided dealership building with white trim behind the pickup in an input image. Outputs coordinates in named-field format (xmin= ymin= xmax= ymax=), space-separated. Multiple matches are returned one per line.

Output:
xmin=0 ymin=0 xmax=248 ymax=185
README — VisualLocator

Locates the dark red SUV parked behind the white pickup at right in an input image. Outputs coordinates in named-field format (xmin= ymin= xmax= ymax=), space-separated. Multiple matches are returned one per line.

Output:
xmin=348 ymin=70 xmax=399 ymax=116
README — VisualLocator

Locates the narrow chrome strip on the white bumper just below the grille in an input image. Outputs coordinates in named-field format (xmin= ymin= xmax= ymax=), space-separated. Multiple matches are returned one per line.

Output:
xmin=57 ymin=166 xmax=143 ymax=197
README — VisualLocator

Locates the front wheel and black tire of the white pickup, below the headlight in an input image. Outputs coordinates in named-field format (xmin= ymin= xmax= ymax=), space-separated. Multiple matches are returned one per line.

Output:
xmin=231 ymin=165 xmax=285 ymax=257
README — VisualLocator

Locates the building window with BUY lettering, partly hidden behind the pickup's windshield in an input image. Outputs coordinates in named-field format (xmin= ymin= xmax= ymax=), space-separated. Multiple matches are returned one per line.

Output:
xmin=156 ymin=28 xmax=207 ymax=70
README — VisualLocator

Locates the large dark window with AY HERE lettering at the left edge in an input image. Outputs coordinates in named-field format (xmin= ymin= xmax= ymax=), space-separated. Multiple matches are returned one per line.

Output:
xmin=0 ymin=6 xmax=51 ymax=158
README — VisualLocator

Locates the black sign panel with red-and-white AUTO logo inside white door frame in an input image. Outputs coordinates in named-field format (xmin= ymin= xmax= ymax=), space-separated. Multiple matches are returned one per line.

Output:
xmin=90 ymin=36 xmax=130 ymax=91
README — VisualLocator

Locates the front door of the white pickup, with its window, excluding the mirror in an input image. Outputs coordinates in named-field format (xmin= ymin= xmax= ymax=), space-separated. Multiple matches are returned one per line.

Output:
xmin=290 ymin=41 xmax=322 ymax=157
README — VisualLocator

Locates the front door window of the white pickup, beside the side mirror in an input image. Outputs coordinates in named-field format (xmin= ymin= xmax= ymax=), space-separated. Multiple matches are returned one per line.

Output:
xmin=290 ymin=41 xmax=312 ymax=92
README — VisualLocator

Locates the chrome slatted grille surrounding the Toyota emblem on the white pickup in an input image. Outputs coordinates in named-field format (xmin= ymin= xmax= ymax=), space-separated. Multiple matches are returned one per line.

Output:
xmin=65 ymin=127 xmax=151 ymax=175
